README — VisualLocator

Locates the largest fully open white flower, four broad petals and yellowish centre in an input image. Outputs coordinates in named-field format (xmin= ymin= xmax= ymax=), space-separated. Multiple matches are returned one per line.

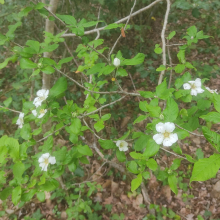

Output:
xmin=153 ymin=122 xmax=178 ymax=147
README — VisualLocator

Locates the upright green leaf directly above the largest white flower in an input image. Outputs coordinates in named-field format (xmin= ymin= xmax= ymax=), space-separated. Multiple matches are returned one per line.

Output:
xmin=163 ymin=98 xmax=179 ymax=122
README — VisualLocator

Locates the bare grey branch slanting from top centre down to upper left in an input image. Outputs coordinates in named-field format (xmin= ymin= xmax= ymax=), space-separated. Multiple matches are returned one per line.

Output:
xmin=61 ymin=0 xmax=163 ymax=37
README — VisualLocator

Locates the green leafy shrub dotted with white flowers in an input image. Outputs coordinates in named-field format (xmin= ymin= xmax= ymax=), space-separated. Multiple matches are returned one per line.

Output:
xmin=0 ymin=0 xmax=220 ymax=219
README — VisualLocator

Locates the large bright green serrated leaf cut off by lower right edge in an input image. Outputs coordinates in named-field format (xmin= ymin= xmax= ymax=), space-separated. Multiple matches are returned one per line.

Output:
xmin=190 ymin=154 xmax=220 ymax=183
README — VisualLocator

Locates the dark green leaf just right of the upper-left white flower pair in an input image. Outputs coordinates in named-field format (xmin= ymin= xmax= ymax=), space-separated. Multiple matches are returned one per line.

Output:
xmin=49 ymin=77 xmax=67 ymax=98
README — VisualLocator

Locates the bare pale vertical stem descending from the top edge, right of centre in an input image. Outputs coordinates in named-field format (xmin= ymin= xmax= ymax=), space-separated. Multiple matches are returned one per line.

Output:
xmin=158 ymin=0 xmax=170 ymax=85
